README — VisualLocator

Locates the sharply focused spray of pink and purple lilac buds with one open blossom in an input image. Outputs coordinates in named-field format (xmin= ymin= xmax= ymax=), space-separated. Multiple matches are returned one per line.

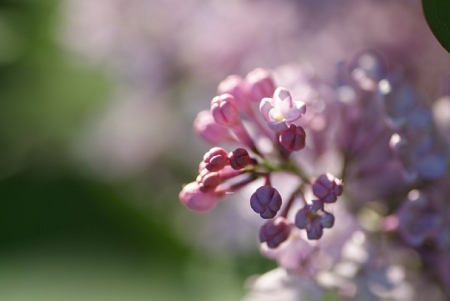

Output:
xmin=179 ymin=69 xmax=343 ymax=248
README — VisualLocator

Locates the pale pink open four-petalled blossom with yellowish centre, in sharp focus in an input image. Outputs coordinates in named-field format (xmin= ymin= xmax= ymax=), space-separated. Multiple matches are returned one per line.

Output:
xmin=259 ymin=87 xmax=306 ymax=132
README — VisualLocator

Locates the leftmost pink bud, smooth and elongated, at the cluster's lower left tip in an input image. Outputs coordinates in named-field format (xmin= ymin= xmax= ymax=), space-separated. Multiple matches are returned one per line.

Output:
xmin=178 ymin=182 xmax=219 ymax=212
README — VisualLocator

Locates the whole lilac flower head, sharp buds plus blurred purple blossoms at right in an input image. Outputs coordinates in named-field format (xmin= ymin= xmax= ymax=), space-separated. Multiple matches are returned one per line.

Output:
xmin=180 ymin=51 xmax=450 ymax=300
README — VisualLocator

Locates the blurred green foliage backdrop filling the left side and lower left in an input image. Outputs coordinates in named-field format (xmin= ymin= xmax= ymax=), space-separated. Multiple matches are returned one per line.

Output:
xmin=0 ymin=0 xmax=274 ymax=301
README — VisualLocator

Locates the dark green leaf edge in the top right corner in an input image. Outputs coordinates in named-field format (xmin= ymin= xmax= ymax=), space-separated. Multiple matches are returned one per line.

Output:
xmin=422 ymin=0 xmax=450 ymax=52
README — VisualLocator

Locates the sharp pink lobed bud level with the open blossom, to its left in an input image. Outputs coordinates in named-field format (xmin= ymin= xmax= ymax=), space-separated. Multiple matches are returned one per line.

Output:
xmin=211 ymin=94 xmax=240 ymax=126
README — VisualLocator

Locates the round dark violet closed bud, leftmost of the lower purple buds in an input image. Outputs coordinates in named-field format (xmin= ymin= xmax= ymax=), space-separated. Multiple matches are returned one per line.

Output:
xmin=250 ymin=185 xmax=282 ymax=219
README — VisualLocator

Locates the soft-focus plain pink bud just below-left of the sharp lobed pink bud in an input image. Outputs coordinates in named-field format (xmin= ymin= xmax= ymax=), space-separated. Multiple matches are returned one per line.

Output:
xmin=194 ymin=111 xmax=235 ymax=144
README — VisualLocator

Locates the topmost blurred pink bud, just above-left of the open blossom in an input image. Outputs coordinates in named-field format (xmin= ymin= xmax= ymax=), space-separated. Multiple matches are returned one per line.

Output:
xmin=245 ymin=68 xmax=275 ymax=102
